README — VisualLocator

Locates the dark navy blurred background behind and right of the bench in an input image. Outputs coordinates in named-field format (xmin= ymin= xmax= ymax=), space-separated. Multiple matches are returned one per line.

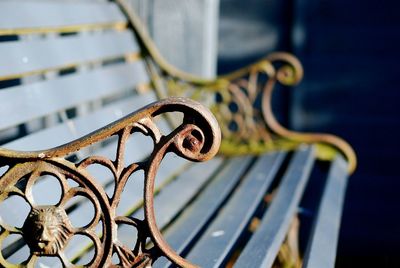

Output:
xmin=218 ymin=0 xmax=400 ymax=267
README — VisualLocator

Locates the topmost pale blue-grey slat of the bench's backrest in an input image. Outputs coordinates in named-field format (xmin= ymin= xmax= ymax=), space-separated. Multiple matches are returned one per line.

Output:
xmin=0 ymin=0 xmax=126 ymax=33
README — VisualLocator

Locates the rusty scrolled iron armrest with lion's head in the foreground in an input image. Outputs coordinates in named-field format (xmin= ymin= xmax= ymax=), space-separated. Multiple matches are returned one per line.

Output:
xmin=0 ymin=98 xmax=221 ymax=267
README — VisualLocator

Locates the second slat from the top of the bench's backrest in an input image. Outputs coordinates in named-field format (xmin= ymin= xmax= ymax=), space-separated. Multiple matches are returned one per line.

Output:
xmin=0 ymin=31 xmax=139 ymax=79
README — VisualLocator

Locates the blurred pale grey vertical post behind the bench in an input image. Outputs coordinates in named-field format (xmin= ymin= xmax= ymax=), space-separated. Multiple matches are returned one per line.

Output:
xmin=130 ymin=0 xmax=219 ymax=78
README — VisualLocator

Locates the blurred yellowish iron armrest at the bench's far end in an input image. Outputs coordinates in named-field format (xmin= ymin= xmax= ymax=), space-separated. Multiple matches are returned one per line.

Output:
xmin=116 ymin=0 xmax=357 ymax=173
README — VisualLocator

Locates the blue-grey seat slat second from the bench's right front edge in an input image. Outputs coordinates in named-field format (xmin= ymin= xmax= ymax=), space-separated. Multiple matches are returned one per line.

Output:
xmin=235 ymin=147 xmax=314 ymax=267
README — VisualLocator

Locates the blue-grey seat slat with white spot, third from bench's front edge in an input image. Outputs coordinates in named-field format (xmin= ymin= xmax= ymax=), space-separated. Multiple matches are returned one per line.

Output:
xmin=187 ymin=153 xmax=285 ymax=267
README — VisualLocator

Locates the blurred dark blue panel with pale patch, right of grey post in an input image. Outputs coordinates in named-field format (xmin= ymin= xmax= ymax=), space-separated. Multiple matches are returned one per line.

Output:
xmin=218 ymin=0 xmax=293 ymax=73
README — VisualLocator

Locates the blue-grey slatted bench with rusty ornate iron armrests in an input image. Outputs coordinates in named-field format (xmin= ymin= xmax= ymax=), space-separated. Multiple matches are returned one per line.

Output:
xmin=0 ymin=0 xmax=356 ymax=267
